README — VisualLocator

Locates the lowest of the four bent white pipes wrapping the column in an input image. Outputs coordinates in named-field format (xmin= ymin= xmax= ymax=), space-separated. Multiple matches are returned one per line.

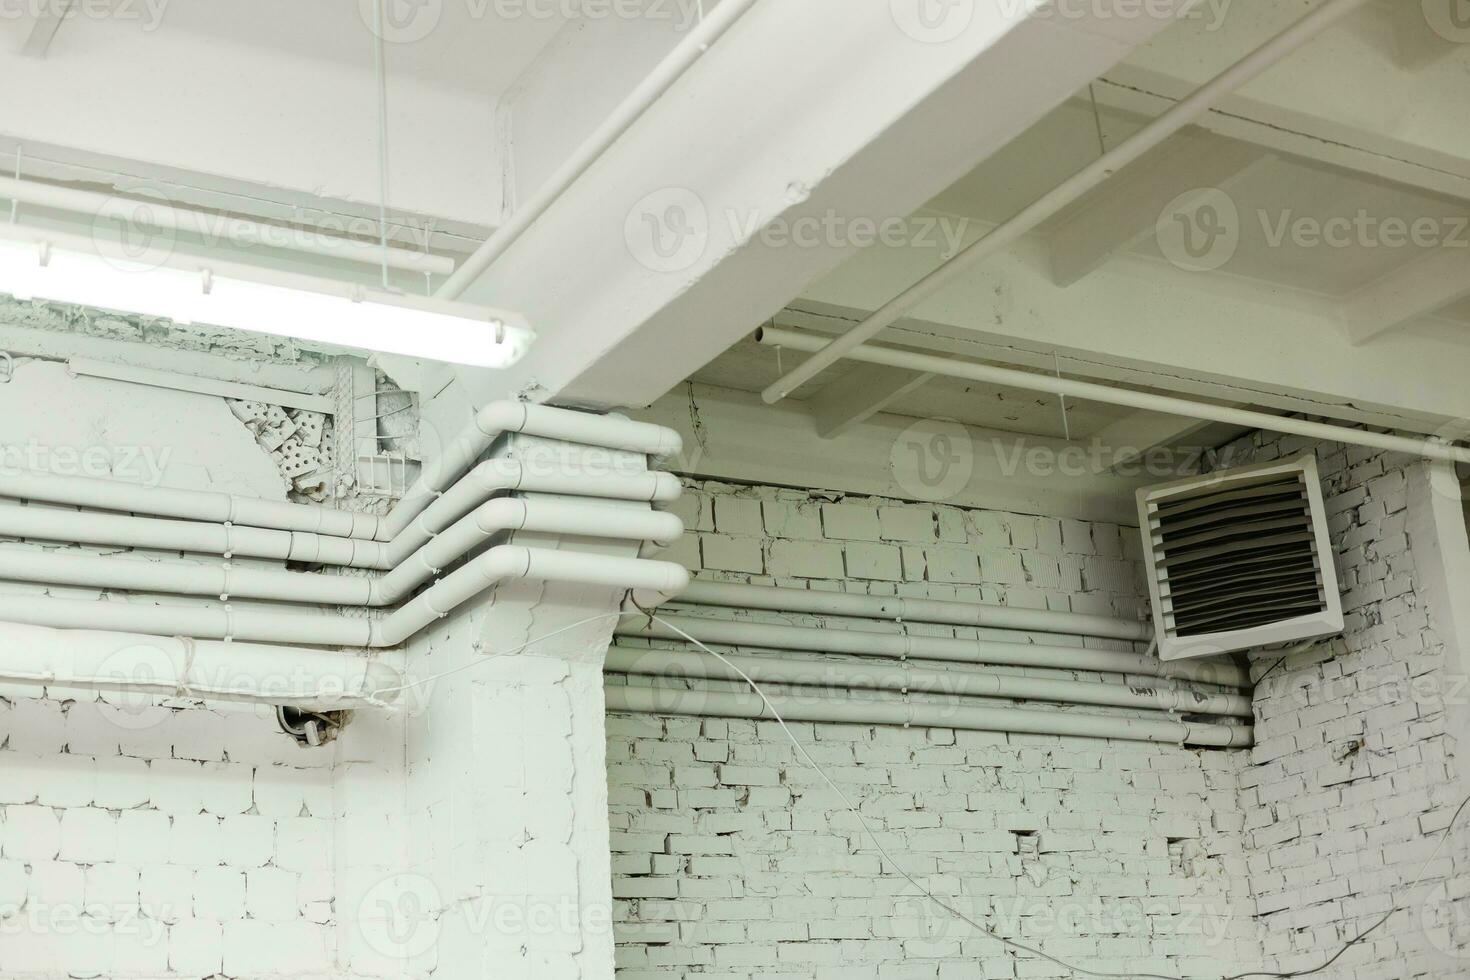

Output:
xmin=0 ymin=545 xmax=689 ymax=646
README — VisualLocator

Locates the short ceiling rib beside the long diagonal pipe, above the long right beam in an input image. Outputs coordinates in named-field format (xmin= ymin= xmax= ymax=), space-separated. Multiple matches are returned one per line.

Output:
xmin=1051 ymin=128 xmax=1270 ymax=287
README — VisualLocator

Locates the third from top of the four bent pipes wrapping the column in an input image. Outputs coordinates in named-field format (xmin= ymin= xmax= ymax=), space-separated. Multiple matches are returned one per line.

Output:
xmin=0 ymin=498 xmax=684 ymax=607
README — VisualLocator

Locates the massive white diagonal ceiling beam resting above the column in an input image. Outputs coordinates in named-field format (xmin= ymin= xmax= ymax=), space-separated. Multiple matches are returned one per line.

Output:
xmin=452 ymin=0 xmax=1199 ymax=404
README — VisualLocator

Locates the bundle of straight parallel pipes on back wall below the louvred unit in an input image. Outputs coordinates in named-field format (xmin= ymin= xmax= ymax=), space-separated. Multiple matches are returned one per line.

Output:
xmin=606 ymin=580 xmax=1252 ymax=748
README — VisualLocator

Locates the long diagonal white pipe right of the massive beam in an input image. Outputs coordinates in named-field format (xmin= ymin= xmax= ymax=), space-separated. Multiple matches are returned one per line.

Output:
xmin=758 ymin=0 xmax=1367 ymax=404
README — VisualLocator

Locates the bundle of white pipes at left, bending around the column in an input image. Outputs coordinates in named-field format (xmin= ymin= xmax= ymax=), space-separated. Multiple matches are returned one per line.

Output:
xmin=0 ymin=401 xmax=688 ymax=710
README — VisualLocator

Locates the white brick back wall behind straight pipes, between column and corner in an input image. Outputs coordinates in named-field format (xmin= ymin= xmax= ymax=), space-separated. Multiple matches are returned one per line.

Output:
xmin=609 ymin=483 xmax=1260 ymax=980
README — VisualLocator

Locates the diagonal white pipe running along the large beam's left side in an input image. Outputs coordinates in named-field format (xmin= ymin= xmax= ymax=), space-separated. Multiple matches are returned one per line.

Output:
xmin=435 ymin=0 xmax=756 ymax=300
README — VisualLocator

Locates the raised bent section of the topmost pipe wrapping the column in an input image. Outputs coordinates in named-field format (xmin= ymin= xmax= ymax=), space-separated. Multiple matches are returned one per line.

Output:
xmin=378 ymin=401 xmax=684 ymax=541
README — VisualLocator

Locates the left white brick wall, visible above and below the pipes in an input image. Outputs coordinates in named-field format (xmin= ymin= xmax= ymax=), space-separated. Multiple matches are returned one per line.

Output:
xmin=0 ymin=361 xmax=364 ymax=980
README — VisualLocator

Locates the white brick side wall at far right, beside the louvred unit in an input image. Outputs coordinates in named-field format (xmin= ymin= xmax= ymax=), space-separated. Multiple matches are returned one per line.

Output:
xmin=1233 ymin=436 xmax=1470 ymax=980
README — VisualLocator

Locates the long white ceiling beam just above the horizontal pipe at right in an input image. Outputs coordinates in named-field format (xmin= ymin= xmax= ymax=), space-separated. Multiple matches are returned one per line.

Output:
xmin=799 ymin=218 xmax=1470 ymax=432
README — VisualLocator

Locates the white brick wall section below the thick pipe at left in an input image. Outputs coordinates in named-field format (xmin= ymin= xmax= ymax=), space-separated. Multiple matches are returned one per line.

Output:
xmin=0 ymin=692 xmax=335 ymax=979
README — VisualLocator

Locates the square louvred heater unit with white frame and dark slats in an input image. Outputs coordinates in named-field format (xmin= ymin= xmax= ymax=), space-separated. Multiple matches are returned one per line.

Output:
xmin=1138 ymin=455 xmax=1342 ymax=660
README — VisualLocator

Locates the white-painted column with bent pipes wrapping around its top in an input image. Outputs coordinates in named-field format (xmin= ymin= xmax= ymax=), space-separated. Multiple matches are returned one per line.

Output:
xmin=340 ymin=423 xmax=647 ymax=980
